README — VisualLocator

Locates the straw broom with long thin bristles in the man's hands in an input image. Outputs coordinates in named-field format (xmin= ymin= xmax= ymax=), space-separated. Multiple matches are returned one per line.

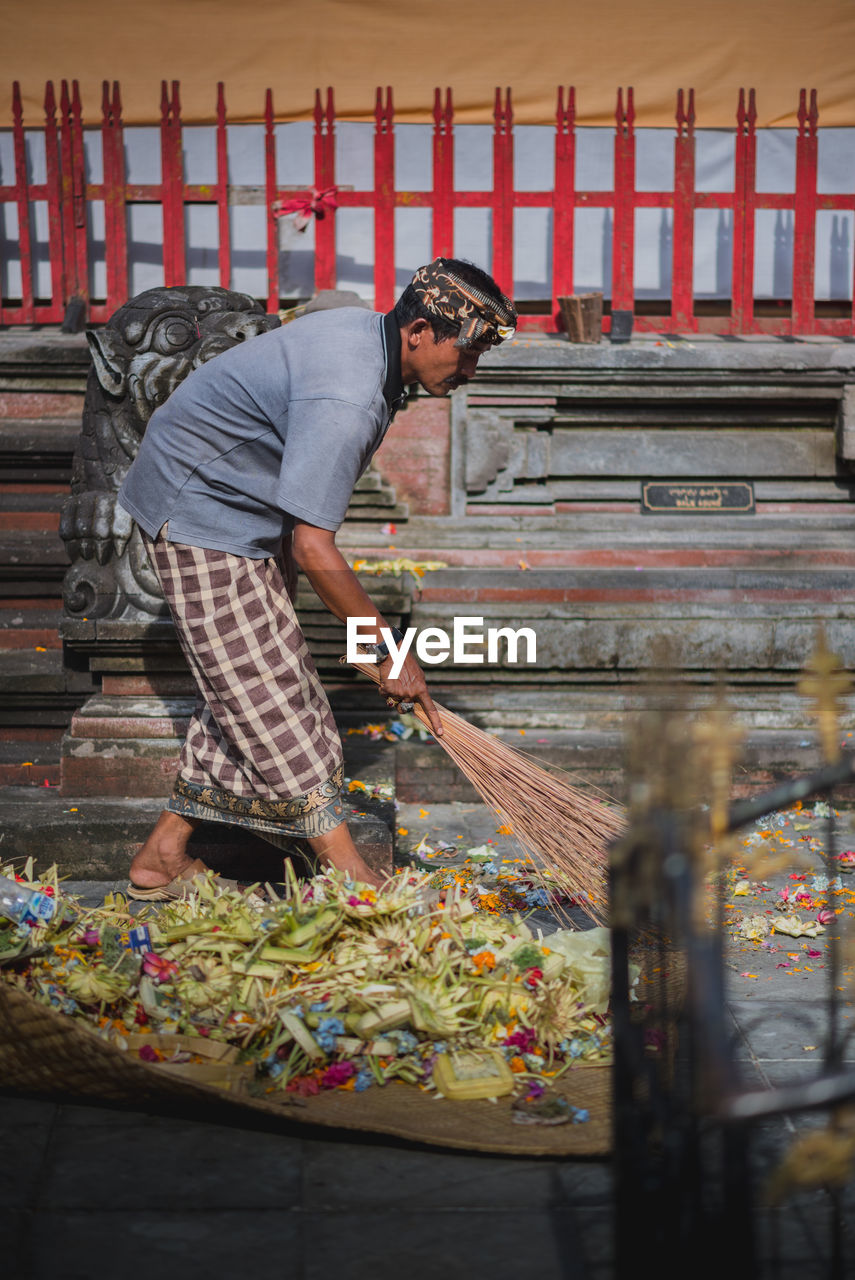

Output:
xmin=342 ymin=659 xmax=625 ymax=924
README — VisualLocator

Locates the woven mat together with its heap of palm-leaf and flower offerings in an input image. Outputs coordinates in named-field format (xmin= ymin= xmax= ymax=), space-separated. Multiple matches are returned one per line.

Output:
xmin=0 ymin=868 xmax=627 ymax=1153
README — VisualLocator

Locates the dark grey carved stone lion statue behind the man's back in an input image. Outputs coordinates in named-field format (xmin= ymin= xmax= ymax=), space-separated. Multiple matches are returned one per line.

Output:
xmin=59 ymin=284 xmax=279 ymax=621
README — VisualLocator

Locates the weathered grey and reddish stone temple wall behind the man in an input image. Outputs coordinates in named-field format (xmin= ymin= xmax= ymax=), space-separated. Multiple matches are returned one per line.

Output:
xmin=0 ymin=302 xmax=855 ymax=796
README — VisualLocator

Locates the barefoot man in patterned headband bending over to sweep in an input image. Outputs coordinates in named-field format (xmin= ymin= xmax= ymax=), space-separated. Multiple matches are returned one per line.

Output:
xmin=119 ymin=259 xmax=517 ymax=901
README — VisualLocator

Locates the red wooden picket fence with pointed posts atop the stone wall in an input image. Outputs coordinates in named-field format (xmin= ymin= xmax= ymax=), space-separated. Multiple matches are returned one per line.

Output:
xmin=0 ymin=81 xmax=855 ymax=335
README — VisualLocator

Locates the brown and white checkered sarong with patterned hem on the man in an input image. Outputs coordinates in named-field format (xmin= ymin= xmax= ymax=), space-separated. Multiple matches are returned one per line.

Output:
xmin=143 ymin=530 xmax=343 ymax=844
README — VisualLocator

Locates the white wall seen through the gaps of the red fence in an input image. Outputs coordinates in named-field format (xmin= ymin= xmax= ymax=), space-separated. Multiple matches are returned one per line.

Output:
xmin=0 ymin=122 xmax=855 ymax=307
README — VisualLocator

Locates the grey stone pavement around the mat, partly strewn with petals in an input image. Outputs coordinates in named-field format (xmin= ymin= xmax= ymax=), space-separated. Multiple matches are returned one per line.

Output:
xmin=0 ymin=804 xmax=855 ymax=1280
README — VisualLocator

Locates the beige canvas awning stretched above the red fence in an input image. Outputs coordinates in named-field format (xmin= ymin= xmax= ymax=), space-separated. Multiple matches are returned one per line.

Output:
xmin=6 ymin=0 xmax=855 ymax=128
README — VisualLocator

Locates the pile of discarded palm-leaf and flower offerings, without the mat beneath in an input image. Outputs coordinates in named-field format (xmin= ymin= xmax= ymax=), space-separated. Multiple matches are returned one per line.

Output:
xmin=0 ymin=865 xmax=611 ymax=1120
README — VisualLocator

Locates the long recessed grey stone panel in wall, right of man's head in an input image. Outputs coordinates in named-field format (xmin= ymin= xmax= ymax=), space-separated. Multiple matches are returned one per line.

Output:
xmin=458 ymin=383 xmax=855 ymax=509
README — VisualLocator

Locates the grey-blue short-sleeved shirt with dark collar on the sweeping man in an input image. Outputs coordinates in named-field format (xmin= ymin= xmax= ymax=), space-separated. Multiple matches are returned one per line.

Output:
xmin=119 ymin=307 xmax=401 ymax=559
